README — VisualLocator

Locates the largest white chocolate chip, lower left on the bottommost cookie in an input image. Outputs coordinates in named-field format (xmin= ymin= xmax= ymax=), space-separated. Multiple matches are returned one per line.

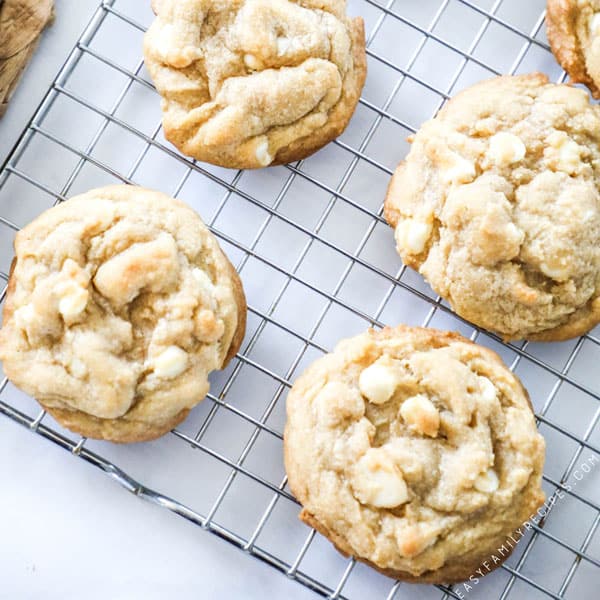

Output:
xmin=352 ymin=448 xmax=409 ymax=508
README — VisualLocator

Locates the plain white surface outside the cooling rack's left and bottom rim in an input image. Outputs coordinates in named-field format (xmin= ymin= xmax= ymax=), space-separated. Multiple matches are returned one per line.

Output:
xmin=0 ymin=0 xmax=314 ymax=600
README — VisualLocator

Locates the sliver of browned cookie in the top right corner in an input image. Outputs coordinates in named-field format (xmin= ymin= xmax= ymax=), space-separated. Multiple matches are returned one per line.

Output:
xmin=546 ymin=0 xmax=600 ymax=98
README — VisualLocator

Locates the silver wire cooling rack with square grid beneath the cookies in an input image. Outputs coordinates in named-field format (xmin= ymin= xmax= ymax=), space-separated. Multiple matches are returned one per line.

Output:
xmin=0 ymin=0 xmax=600 ymax=600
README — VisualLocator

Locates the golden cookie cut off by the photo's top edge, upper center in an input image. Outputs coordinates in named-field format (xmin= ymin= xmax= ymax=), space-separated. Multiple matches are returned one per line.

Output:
xmin=144 ymin=0 xmax=366 ymax=169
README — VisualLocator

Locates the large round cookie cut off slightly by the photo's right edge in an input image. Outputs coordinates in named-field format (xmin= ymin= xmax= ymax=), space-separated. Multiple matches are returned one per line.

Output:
xmin=385 ymin=74 xmax=600 ymax=340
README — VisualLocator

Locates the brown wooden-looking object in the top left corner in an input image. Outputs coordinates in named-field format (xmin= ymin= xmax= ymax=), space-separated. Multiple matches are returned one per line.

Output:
xmin=0 ymin=0 xmax=54 ymax=117
